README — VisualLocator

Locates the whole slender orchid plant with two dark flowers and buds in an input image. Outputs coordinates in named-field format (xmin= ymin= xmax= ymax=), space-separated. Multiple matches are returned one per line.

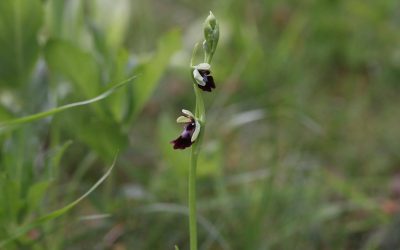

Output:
xmin=171 ymin=11 xmax=219 ymax=250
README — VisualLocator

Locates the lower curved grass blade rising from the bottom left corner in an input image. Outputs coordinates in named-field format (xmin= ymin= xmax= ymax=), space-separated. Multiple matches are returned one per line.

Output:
xmin=0 ymin=156 xmax=117 ymax=248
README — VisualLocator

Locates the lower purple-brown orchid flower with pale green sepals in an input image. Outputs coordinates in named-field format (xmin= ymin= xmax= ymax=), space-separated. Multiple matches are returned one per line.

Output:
xmin=171 ymin=109 xmax=200 ymax=149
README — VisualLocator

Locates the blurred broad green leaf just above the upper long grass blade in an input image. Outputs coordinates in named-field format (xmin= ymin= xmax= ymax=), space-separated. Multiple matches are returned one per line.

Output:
xmin=44 ymin=40 xmax=100 ymax=98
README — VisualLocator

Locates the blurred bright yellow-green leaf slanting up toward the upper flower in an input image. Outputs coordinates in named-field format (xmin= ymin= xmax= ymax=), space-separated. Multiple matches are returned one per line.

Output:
xmin=133 ymin=29 xmax=181 ymax=116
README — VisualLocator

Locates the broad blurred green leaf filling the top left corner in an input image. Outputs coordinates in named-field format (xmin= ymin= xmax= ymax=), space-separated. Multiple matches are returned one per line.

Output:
xmin=0 ymin=0 xmax=43 ymax=86
